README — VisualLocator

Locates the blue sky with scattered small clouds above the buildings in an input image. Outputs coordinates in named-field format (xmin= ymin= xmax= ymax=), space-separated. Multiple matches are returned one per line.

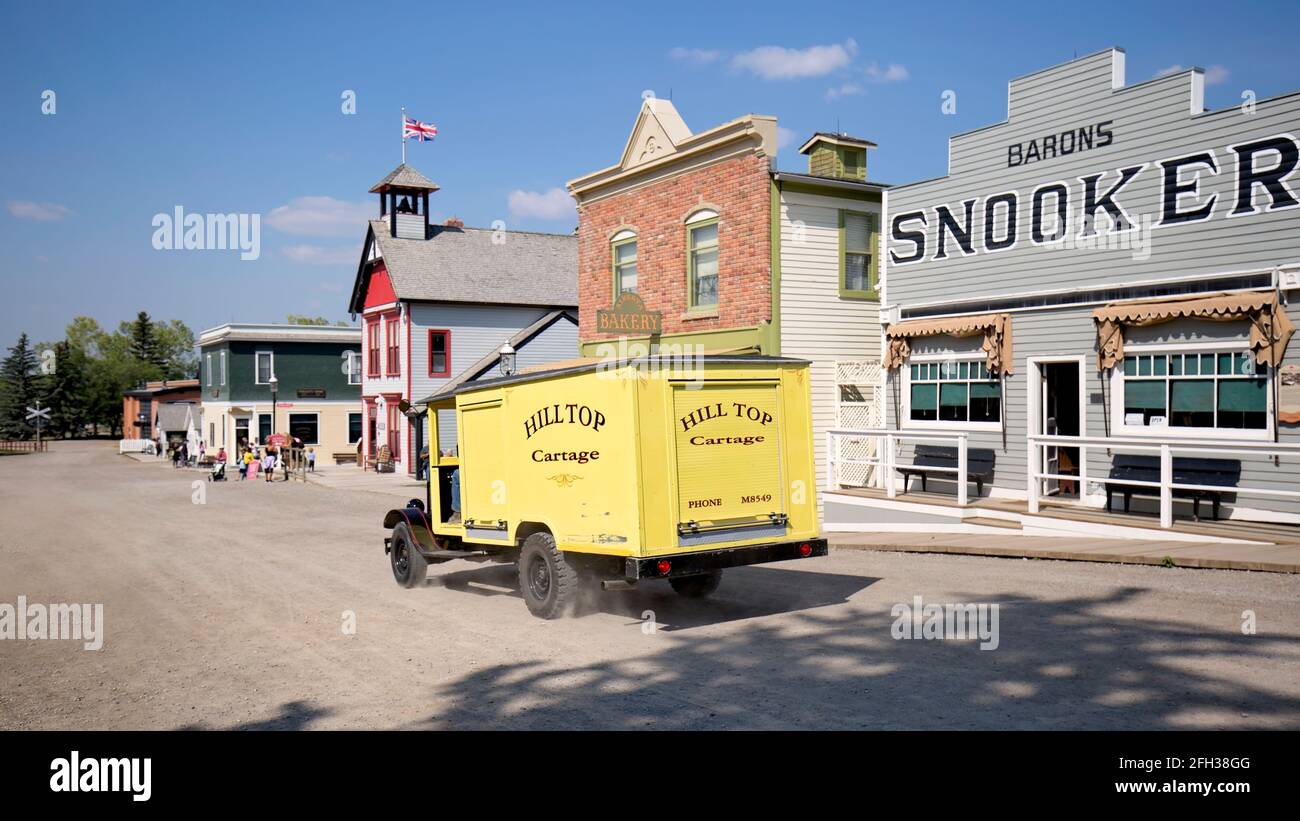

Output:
xmin=0 ymin=0 xmax=1300 ymax=347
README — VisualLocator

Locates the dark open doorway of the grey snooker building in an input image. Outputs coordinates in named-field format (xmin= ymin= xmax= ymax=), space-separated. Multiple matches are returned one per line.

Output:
xmin=1031 ymin=357 xmax=1084 ymax=499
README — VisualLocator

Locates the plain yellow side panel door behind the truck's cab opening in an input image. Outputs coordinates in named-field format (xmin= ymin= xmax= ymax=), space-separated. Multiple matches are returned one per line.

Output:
xmin=460 ymin=401 xmax=510 ymax=540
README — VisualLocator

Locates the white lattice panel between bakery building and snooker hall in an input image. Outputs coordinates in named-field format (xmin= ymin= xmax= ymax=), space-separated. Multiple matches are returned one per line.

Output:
xmin=828 ymin=360 xmax=884 ymax=487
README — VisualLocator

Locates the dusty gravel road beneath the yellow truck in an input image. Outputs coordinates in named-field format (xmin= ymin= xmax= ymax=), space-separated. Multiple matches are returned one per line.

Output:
xmin=0 ymin=443 xmax=1300 ymax=729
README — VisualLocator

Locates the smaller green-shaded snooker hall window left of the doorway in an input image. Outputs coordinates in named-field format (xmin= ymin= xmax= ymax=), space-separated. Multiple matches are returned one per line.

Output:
xmin=909 ymin=360 xmax=1002 ymax=422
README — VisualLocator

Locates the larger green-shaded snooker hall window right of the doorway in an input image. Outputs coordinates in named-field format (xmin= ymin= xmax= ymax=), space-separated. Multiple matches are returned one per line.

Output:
xmin=1122 ymin=351 xmax=1269 ymax=430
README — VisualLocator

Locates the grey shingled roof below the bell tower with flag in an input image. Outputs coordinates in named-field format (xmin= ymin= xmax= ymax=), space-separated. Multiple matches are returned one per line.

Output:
xmin=350 ymin=220 xmax=577 ymax=313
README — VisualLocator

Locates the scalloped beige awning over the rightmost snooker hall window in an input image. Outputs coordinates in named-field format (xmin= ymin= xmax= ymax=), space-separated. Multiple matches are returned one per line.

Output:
xmin=1092 ymin=291 xmax=1295 ymax=370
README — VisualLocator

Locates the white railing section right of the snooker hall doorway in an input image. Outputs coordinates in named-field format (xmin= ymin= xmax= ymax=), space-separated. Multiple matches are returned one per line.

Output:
xmin=1026 ymin=435 xmax=1300 ymax=529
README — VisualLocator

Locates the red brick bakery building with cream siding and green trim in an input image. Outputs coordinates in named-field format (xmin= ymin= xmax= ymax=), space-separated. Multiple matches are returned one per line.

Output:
xmin=568 ymin=97 xmax=887 ymax=504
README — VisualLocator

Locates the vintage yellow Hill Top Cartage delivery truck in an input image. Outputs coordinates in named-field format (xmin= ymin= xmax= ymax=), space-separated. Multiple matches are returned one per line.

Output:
xmin=384 ymin=356 xmax=827 ymax=618
